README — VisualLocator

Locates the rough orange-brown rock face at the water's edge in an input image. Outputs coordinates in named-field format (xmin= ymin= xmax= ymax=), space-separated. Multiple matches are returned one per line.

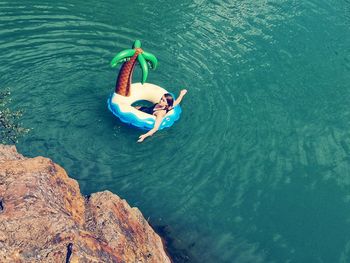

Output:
xmin=0 ymin=145 xmax=170 ymax=263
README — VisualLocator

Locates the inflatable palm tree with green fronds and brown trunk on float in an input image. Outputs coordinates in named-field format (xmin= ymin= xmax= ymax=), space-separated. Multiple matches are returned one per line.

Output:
xmin=111 ymin=40 xmax=158 ymax=97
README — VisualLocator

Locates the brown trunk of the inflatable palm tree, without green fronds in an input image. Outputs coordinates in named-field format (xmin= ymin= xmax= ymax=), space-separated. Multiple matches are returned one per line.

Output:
xmin=115 ymin=48 xmax=142 ymax=97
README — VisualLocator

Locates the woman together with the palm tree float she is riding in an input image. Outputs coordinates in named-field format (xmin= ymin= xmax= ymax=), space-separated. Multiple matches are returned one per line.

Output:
xmin=108 ymin=40 xmax=187 ymax=142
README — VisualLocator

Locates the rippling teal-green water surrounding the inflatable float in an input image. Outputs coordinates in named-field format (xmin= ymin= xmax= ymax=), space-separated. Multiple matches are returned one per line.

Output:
xmin=0 ymin=0 xmax=350 ymax=263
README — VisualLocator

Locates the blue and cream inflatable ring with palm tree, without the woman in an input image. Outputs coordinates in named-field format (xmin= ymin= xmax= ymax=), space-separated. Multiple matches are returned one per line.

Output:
xmin=107 ymin=40 xmax=181 ymax=130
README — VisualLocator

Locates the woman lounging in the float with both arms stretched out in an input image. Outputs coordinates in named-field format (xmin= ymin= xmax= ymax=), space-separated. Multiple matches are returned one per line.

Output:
xmin=136 ymin=89 xmax=187 ymax=142
